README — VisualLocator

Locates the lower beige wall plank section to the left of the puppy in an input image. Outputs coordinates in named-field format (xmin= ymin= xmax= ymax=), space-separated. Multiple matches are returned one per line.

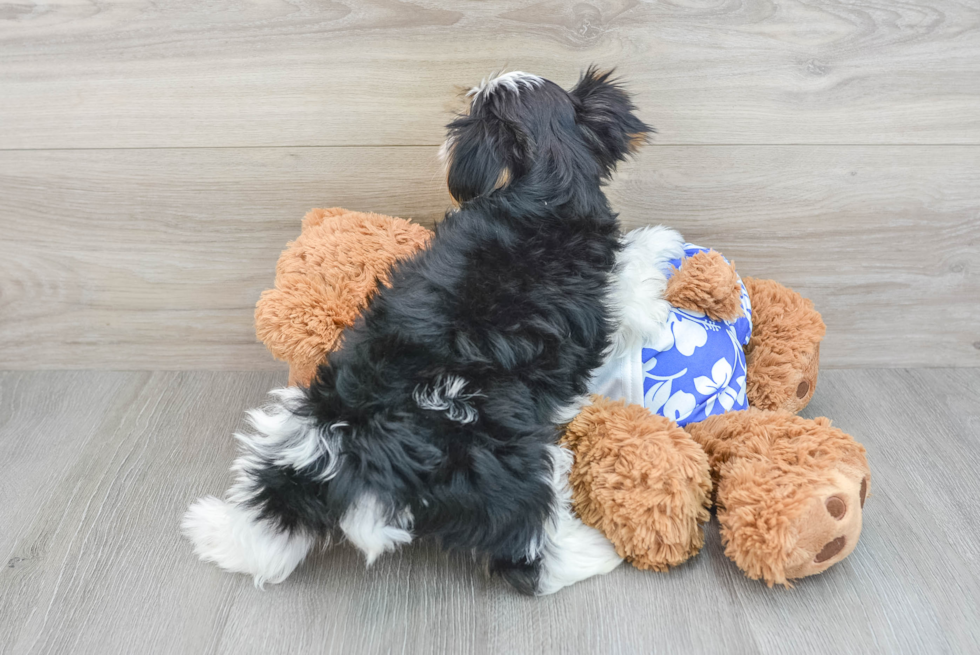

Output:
xmin=0 ymin=148 xmax=448 ymax=370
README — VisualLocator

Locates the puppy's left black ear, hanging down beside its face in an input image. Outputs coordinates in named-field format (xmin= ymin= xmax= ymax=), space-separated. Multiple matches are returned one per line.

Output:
xmin=441 ymin=106 xmax=529 ymax=203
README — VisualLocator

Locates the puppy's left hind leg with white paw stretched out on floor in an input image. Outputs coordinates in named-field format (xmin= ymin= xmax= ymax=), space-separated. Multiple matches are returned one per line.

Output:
xmin=181 ymin=388 xmax=339 ymax=587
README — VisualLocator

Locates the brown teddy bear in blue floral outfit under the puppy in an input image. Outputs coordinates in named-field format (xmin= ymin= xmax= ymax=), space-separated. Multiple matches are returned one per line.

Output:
xmin=255 ymin=208 xmax=870 ymax=586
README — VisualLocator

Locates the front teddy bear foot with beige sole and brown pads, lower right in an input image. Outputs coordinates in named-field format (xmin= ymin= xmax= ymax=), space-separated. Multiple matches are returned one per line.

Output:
xmin=687 ymin=408 xmax=871 ymax=587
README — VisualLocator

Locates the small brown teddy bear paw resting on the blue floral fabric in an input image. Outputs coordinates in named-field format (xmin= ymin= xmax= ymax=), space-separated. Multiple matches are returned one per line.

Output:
xmin=664 ymin=250 xmax=742 ymax=321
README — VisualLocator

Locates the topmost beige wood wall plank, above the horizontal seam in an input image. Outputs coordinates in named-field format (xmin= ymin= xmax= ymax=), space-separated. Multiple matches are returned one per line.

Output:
xmin=0 ymin=0 xmax=980 ymax=148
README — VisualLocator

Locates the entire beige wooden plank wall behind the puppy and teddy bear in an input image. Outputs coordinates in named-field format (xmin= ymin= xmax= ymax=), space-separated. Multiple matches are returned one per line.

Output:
xmin=0 ymin=0 xmax=980 ymax=369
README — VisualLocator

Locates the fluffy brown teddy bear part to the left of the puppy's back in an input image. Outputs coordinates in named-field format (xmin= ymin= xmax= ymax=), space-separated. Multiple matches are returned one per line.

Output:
xmin=255 ymin=207 xmax=432 ymax=386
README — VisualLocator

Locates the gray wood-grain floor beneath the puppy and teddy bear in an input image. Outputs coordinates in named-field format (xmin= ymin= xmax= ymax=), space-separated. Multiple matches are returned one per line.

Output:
xmin=0 ymin=369 xmax=980 ymax=654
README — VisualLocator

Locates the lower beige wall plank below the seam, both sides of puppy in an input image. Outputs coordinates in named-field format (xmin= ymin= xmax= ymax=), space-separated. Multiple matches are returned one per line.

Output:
xmin=0 ymin=146 xmax=980 ymax=370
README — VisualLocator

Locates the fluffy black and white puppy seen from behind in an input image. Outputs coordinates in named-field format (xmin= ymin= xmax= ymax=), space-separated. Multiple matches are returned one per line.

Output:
xmin=183 ymin=69 xmax=650 ymax=594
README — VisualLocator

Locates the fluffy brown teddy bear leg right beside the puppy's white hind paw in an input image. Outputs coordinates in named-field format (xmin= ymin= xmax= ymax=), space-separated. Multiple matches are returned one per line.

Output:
xmin=564 ymin=396 xmax=711 ymax=571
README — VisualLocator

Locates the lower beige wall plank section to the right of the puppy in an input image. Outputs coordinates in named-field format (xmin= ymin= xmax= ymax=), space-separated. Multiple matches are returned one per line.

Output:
xmin=612 ymin=146 xmax=980 ymax=367
